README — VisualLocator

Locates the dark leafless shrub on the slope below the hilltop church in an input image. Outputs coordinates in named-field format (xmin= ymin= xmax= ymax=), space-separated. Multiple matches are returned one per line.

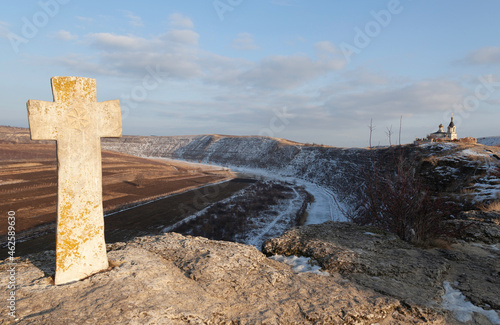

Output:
xmin=349 ymin=147 xmax=454 ymax=243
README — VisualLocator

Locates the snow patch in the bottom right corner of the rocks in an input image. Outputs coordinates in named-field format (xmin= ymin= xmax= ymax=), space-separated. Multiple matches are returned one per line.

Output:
xmin=442 ymin=281 xmax=500 ymax=324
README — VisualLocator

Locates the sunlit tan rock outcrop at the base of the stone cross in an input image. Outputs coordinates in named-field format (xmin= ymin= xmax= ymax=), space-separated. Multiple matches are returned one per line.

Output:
xmin=0 ymin=233 xmax=444 ymax=324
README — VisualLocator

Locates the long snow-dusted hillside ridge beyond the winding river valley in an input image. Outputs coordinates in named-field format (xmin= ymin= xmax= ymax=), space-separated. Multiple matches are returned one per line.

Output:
xmin=103 ymin=135 xmax=371 ymax=208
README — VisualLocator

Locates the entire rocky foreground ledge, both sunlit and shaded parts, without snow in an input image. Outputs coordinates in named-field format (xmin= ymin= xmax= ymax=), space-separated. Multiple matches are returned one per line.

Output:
xmin=0 ymin=223 xmax=500 ymax=325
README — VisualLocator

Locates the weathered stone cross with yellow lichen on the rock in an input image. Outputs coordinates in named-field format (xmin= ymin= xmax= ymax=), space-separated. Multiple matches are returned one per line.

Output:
xmin=26 ymin=77 xmax=122 ymax=284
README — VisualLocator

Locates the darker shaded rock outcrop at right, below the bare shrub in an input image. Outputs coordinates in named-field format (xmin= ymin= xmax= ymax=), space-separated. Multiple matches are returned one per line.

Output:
xmin=263 ymin=222 xmax=500 ymax=324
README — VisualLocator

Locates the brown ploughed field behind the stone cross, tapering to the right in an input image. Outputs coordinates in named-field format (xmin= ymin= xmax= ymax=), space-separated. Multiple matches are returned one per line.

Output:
xmin=0 ymin=142 xmax=234 ymax=238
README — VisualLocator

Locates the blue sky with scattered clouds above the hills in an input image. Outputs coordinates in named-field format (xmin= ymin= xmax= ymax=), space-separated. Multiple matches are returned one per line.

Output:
xmin=0 ymin=0 xmax=500 ymax=147
